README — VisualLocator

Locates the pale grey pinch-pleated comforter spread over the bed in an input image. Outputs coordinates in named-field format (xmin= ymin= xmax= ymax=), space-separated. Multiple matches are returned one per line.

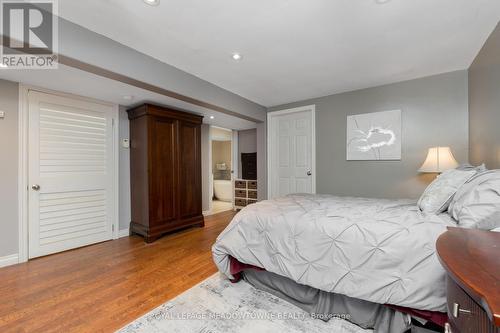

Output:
xmin=212 ymin=195 xmax=454 ymax=312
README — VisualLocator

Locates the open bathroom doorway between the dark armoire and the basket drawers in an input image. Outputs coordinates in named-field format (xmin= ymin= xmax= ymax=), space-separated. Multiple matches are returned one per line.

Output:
xmin=210 ymin=126 xmax=235 ymax=214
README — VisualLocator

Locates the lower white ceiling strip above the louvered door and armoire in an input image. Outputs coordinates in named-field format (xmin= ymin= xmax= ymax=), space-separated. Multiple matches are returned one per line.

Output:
xmin=0 ymin=65 xmax=257 ymax=130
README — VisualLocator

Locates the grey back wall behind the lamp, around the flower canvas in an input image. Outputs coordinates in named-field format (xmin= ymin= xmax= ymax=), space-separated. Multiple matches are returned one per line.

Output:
xmin=269 ymin=71 xmax=468 ymax=198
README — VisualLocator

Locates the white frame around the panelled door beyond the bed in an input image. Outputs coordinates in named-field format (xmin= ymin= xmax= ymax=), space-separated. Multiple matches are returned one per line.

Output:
xmin=267 ymin=104 xmax=316 ymax=198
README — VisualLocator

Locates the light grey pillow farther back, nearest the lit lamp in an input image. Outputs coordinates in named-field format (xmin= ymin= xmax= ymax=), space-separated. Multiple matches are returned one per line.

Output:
xmin=418 ymin=169 xmax=476 ymax=214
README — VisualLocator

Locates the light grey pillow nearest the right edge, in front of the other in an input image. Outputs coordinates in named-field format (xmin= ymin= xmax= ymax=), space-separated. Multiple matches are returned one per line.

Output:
xmin=448 ymin=170 xmax=500 ymax=230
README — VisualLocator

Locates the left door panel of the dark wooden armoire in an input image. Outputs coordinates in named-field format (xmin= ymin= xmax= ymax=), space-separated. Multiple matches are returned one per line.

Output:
xmin=149 ymin=117 xmax=177 ymax=227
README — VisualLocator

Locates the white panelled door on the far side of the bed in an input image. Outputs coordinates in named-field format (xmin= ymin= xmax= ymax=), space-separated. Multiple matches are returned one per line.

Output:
xmin=268 ymin=106 xmax=316 ymax=198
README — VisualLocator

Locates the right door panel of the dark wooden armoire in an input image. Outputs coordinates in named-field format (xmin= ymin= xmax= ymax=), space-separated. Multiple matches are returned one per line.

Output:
xmin=178 ymin=121 xmax=201 ymax=218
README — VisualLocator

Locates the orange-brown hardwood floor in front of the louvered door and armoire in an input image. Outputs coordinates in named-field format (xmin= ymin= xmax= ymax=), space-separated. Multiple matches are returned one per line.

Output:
xmin=0 ymin=211 xmax=235 ymax=333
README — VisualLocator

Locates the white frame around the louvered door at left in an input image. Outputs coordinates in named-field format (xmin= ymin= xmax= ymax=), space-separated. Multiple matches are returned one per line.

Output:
xmin=17 ymin=84 xmax=120 ymax=263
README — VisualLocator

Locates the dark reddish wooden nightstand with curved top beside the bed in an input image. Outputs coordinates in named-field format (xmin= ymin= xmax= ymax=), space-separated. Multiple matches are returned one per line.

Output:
xmin=436 ymin=228 xmax=500 ymax=333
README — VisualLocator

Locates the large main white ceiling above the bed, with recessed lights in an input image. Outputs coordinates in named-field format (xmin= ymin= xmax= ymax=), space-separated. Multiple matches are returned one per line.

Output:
xmin=59 ymin=0 xmax=500 ymax=106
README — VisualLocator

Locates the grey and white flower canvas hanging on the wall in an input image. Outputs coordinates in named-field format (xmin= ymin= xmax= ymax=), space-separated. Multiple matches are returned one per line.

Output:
xmin=347 ymin=110 xmax=401 ymax=161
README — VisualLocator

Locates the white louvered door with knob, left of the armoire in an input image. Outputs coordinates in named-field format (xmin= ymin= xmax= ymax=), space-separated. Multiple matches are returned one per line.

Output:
xmin=28 ymin=90 xmax=116 ymax=258
